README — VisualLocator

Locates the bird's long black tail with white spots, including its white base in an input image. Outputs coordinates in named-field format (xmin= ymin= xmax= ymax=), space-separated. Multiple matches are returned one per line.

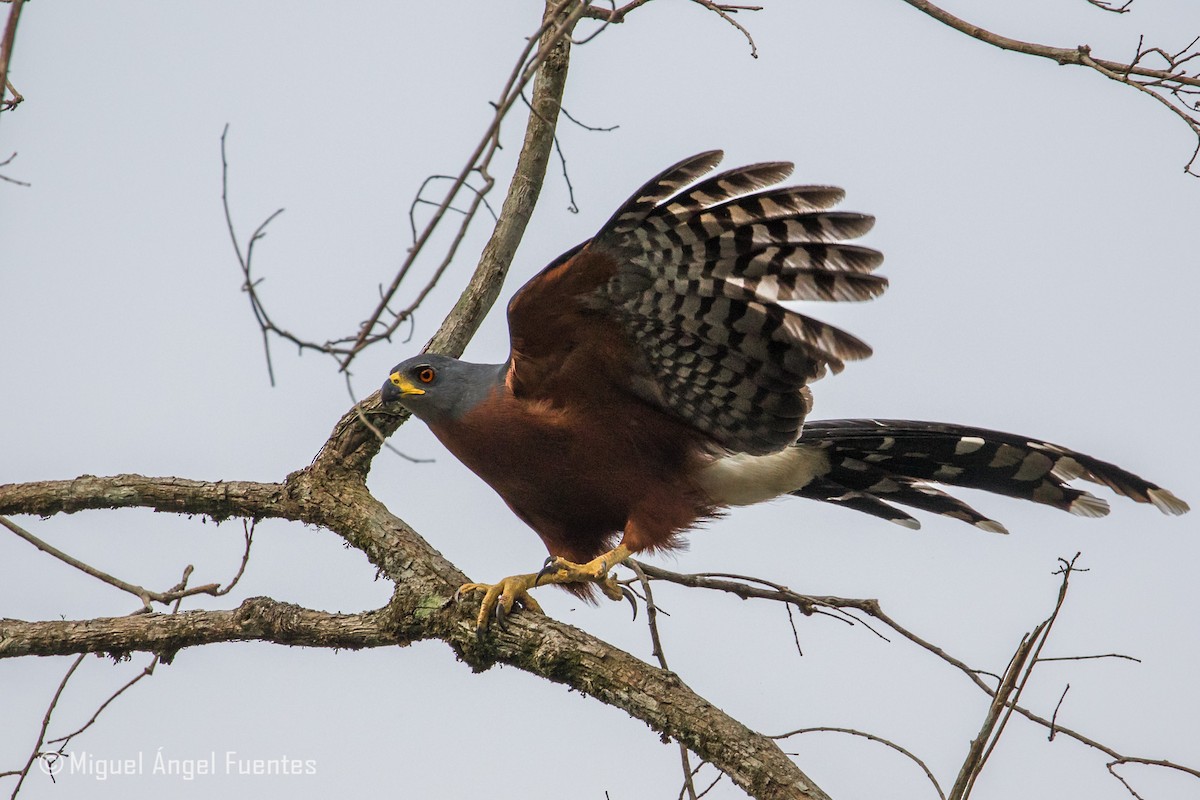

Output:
xmin=701 ymin=420 xmax=1188 ymax=534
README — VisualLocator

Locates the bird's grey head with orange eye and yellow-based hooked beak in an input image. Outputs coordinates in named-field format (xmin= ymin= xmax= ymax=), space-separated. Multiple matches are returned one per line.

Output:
xmin=379 ymin=353 xmax=506 ymax=422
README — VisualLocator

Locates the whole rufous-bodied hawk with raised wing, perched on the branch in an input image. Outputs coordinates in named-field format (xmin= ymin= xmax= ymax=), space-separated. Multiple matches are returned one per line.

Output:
xmin=382 ymin=151 xmax=1188 ymax=630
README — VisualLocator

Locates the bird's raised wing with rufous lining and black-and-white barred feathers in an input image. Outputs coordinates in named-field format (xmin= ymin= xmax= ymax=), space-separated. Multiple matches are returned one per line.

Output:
xmin=509 ymin=151 xmax=887 ymax=455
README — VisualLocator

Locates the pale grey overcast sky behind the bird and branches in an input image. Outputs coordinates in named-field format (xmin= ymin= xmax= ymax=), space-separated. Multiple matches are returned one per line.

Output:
xmin=0 ymin=0 xmax=1200 ymax=800
